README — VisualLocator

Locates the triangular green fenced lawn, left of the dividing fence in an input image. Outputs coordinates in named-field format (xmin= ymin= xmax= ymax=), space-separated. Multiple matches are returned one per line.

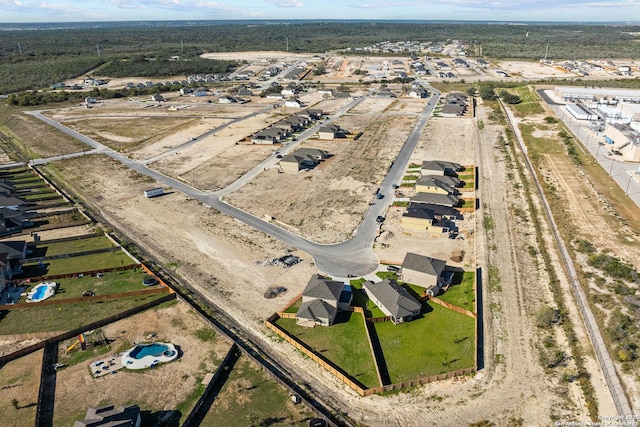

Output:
xmin=276 ymin=312 xmax=380 ymax=388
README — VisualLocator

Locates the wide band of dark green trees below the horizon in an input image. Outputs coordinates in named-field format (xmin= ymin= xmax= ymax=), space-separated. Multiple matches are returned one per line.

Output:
xmin=0 ymin=21 xmax=640 ymax=93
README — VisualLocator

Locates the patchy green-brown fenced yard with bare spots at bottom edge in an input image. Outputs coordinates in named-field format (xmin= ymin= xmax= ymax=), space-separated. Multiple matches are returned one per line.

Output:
xmin=202 ymin=357 xmax=314 ymax=426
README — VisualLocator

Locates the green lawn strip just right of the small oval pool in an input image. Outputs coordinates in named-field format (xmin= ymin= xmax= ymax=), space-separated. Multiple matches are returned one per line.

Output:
xmin=20 ymin=268 xmax=149 ymax=302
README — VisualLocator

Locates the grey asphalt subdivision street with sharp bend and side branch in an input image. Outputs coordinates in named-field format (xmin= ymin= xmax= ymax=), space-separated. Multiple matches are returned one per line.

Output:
xmin=27 ymin=89 xmax=440 ymax=277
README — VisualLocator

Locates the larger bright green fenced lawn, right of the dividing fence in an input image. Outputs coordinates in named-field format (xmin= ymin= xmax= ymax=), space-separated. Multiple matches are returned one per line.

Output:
xmin=374 ymin=304 xmax=475 ymax=383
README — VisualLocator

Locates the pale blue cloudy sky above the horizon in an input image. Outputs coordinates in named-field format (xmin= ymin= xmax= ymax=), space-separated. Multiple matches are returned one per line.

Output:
xmin=0 ymin=0 xmax=640 ymax=23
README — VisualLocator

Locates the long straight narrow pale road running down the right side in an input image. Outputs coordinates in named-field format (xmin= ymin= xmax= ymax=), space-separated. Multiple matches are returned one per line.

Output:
xmin=500 ymin=100 xmax=635 ymax=418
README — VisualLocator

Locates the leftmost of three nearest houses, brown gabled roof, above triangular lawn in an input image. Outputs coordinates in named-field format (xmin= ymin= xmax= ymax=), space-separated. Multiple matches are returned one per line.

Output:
xmin=296 ymin=274 xmax=353 ymax=327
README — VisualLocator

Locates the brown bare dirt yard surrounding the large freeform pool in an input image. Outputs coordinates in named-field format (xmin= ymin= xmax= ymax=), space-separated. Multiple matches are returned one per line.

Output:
xmin=54 ymin=303 xmax=231 ymax=425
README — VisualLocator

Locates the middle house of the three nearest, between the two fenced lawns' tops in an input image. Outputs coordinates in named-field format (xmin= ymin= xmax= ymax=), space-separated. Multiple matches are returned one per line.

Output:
xmin=362 ymin=279 xmax=422 ymax=325
